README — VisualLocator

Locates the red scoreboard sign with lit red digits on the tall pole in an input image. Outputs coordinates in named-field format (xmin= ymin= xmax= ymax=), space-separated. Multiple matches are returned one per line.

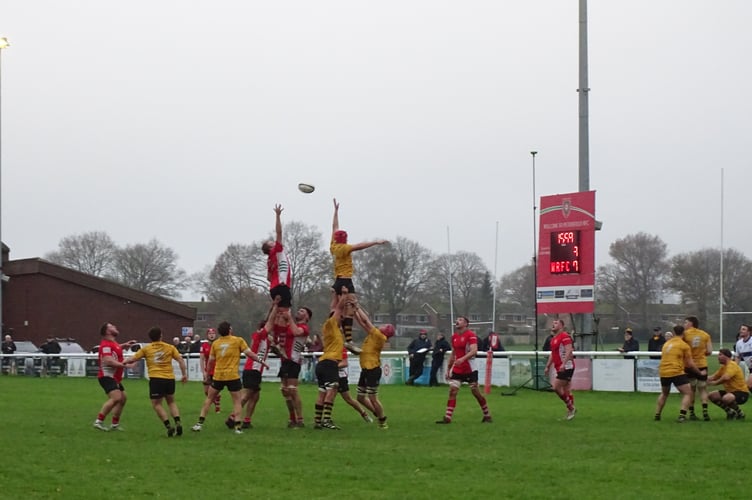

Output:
xmin=536 ymin=191 xmax=595 ymax=314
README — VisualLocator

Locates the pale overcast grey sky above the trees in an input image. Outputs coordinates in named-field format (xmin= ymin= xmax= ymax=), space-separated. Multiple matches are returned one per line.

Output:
xmin=0 ymin=0 xmax=752 ymax=298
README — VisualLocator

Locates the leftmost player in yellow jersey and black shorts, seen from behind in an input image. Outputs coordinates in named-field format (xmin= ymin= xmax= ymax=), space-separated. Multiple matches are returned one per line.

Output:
xmin=124 ymin=326 xmax=188 ymax=437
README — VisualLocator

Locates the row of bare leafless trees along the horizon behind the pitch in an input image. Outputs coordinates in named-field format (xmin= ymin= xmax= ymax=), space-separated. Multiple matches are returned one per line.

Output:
xmin=45 ymin=229 xmax=752 ymax=336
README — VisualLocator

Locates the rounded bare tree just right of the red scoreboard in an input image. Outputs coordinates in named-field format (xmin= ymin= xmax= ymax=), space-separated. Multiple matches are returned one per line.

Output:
xmin=609 ymin=233 xmax=669 ymax=326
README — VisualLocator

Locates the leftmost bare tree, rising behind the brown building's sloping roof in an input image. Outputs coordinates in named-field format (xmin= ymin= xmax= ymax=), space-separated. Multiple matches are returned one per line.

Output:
xmin=45 ymin=231 xmax=118 ymax=277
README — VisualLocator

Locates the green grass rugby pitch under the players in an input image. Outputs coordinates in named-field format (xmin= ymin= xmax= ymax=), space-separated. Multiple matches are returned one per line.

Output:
xmin=0 ymin=376 xmax=749 ymax=499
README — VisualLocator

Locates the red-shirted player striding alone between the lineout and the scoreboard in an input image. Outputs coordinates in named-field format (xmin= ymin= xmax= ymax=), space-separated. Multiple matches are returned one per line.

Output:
xmin=436 ymin=316 xmax=493 ymax=424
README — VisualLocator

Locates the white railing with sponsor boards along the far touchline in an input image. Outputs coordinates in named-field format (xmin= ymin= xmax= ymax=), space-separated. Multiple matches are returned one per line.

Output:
xmin=0 ymin=351 xmax=704 ymax=392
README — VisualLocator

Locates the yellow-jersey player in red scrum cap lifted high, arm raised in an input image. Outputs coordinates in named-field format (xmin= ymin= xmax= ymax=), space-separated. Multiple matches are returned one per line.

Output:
xmin=329 ymin=198 xmax=389 ymax=354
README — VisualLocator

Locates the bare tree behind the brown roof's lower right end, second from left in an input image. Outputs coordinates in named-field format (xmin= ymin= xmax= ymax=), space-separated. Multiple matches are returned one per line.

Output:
xmin=113 ymin=239 xmax=187 ymax=297
